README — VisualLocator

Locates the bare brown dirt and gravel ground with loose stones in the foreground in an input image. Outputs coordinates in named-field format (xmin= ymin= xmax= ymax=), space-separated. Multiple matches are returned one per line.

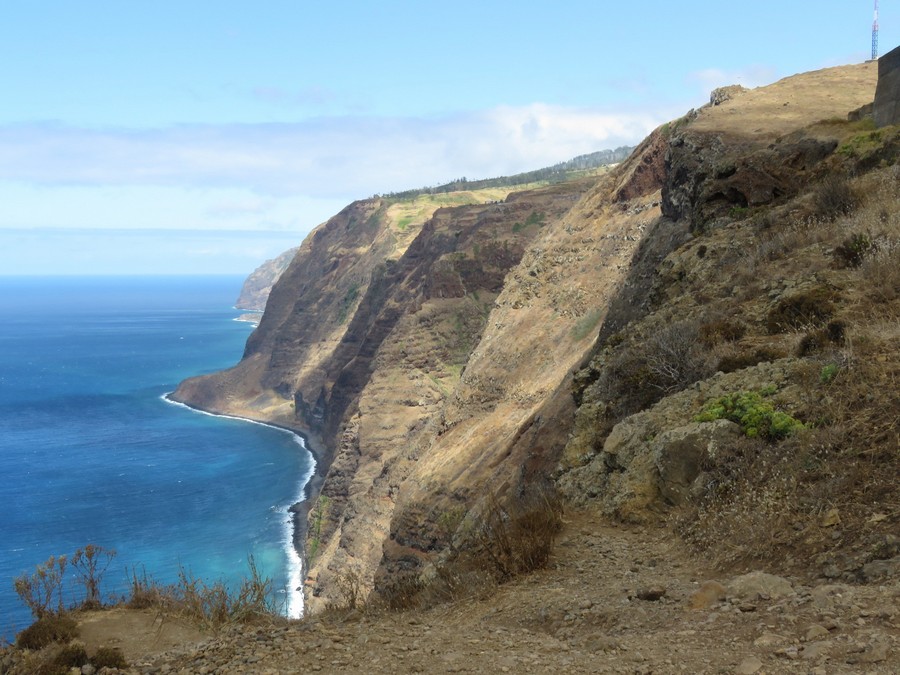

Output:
xmin=15 ymin=511 xmax=900 ymax=675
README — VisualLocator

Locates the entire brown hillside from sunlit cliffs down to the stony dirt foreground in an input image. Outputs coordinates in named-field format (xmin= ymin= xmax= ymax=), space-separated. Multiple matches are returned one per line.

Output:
xmin=3 ymin=63 xmax=900 ymax=673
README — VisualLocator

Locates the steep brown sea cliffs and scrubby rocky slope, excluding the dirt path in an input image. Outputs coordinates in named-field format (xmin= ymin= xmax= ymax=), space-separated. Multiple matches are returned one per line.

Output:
xmin=176 ymin=64 xmax=898 ymax=609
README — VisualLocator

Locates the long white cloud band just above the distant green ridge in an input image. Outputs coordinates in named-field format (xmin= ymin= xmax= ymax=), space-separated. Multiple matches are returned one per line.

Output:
xmin=0 ymin=104 xmax=667 ymax=198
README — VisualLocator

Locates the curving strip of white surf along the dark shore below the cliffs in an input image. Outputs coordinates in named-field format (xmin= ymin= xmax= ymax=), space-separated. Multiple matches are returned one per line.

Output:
xmin=160 ymin=391 xmax=324 ymax=618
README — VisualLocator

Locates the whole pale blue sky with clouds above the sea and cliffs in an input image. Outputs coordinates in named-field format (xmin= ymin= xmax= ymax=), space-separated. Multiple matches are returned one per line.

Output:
xmin=0 ymin=0 xmax=900 ymax=275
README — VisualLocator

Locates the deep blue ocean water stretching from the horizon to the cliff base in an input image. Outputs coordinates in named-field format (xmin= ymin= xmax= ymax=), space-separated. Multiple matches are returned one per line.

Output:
xmin=0 ymin=277 xmax=312 ymax=638
